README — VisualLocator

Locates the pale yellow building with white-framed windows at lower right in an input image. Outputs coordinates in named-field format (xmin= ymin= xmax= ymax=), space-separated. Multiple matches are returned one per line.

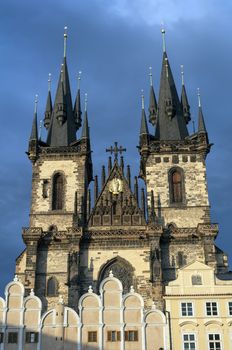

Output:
xmin=165 ymin=261 xmax=232 ymax=350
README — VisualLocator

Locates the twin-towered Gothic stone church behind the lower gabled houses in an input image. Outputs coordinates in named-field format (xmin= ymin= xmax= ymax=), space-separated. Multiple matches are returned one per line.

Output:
xmin=0 ymin=30 xmax=231 ymax=350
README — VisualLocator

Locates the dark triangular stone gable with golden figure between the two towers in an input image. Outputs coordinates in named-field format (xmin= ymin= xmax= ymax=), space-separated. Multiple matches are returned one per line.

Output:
xmin=89 ymin=162 xmax=146 ymax=227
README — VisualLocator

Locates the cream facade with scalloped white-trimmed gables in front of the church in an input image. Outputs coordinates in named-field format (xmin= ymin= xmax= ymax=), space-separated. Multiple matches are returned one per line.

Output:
xmin=0 ymin=273 xmax=168 ymax=350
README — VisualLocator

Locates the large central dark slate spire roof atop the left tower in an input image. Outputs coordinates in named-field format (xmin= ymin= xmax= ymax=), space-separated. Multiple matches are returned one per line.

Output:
xmin=47 ymin=57 xmax=76 ymax=146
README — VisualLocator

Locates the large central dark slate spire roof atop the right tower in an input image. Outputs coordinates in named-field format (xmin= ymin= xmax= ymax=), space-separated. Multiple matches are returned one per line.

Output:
xmin=155 ymin=52 xmax=188 ymax=140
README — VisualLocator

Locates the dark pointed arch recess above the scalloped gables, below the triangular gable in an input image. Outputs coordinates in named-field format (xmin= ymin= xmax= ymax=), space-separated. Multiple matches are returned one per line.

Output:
xmin=98 ymin=256 xmax=135 ymax=294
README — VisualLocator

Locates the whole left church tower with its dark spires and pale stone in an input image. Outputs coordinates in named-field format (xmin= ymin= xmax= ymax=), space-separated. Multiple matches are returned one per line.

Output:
xmin=16 ymin=33 xmax=92 ymax=307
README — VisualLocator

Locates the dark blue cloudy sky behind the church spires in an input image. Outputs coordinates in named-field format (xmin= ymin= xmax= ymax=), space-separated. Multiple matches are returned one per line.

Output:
xmin=0 ymin=0 xmax=232 ymax=294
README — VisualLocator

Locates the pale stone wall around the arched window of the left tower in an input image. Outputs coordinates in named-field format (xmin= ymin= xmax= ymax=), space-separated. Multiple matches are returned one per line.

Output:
xmin=30 ymin=154 xmax=86 ymax=231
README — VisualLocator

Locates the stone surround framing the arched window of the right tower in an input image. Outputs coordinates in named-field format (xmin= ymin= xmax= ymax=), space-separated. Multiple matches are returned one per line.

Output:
xmin=168 ymin=166 xmax=186 ymax=207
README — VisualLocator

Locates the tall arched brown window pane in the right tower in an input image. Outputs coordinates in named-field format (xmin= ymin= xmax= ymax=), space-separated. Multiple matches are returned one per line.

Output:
xmin=169 ymin=169 xmax=184 ymax=203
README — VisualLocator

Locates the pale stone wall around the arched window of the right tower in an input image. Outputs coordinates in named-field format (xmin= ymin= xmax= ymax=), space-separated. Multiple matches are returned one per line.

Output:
xmin=146 ymin=154 xmax=210 ymax=227
